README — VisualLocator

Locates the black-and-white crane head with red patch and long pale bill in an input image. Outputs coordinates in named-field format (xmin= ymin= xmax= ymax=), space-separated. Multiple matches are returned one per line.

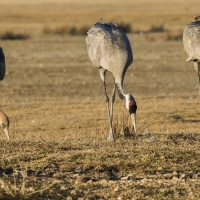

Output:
xmin=125 ymin=94 xmax=137 ymax=132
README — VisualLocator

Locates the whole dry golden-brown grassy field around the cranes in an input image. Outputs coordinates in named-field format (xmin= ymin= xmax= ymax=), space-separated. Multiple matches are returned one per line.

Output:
xmin=0 ymin=0 xmax=200 ymax=200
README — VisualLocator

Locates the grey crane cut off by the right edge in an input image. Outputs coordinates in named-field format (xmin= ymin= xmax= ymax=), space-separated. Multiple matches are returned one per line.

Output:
xmin=183 ymin=16 xmax=200 ymax=94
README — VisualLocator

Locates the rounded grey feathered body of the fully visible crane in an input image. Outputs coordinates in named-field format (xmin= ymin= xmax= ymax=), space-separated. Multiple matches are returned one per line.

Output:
xmin=86 ymin=22 xmax=133 ymax=69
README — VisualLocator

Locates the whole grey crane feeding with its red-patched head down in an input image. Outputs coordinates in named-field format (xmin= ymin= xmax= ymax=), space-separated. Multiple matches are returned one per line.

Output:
xmin=86 ymin=19 xmax=137 ymax=140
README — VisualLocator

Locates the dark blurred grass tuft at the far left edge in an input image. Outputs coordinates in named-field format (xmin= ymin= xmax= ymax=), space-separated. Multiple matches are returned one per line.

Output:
xmin=0 ymin=31 xmax=30 ymax=40
